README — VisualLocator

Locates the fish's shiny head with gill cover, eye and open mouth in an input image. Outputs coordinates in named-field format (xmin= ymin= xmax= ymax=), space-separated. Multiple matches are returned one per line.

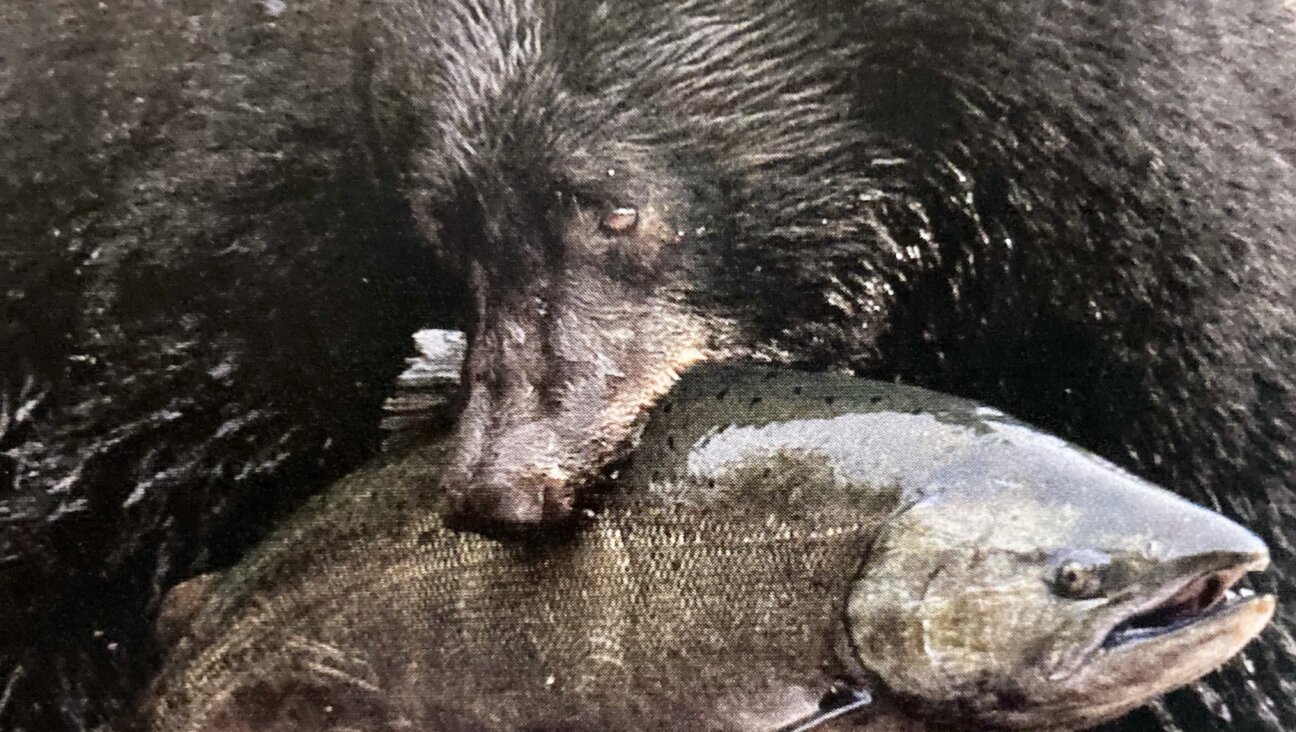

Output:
xmin=846 ymin=428 xmax=1275 ymax=729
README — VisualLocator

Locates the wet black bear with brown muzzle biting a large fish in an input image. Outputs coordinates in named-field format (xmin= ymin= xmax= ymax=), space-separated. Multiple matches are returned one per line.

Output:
xmin=0 ymin=0 xmax=1296 ymax=729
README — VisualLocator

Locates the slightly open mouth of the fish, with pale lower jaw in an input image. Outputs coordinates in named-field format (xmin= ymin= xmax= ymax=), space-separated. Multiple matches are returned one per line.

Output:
xmin=1102 ymin=556 xmax=1273 ymax=650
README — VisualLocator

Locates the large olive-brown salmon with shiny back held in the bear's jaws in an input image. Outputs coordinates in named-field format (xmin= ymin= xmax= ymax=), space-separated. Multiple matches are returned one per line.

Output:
xmin=153 ymin=367 xmax=1274 ymax=731
